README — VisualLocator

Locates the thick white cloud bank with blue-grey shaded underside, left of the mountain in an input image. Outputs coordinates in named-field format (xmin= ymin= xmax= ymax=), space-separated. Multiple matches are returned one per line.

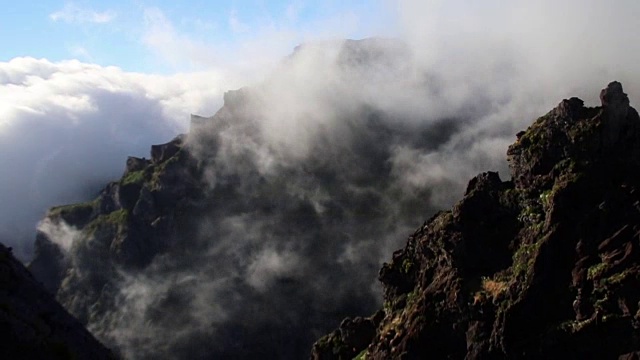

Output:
xmin=0 ymin=58 xmax=244 ymax=260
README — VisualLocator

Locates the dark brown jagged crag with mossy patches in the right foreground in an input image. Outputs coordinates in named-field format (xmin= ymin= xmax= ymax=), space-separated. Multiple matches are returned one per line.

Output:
xmin=312 ymin=82 xmax=640 ymax=359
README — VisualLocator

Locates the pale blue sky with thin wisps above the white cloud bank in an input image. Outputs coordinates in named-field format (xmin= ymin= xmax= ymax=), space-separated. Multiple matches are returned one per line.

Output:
xmin=0 ymin=0 xmax=394 ymax=74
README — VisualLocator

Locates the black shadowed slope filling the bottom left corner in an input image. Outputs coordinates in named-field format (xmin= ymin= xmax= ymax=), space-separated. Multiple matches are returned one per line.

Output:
xmin=0 ymin=244 xmax=115 ymax=359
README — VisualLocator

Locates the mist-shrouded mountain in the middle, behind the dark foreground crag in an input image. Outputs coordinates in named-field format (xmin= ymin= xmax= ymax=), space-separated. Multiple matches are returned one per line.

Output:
xmin=30 ymin=39 xmax=483 ymax=359
